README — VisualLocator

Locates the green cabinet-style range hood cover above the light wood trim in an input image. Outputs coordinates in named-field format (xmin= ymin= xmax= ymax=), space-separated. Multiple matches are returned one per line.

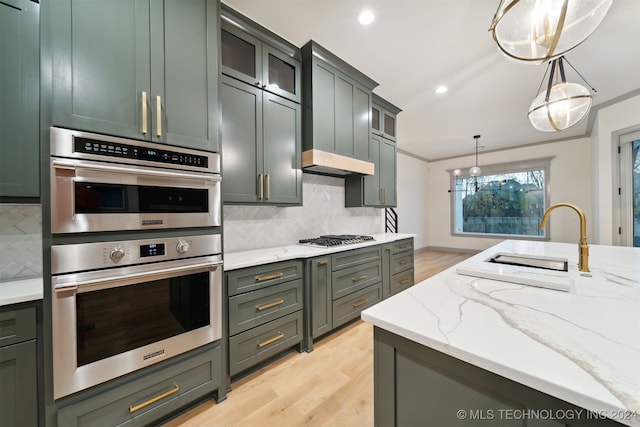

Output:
xmin=302 ymin=40 xmax=378 ymax=161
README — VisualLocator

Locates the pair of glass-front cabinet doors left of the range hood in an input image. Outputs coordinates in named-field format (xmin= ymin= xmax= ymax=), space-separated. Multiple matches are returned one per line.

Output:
xmin=221 ymin=19 xmax=301 ymax=103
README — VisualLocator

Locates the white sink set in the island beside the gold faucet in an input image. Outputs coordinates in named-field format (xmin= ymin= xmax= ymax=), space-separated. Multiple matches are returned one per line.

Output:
xmin=456 ymin=252 xmax=572 ymax=292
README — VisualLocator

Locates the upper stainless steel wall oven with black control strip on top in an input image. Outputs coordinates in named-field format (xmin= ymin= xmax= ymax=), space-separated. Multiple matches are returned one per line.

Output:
xmin=50 ymin=128 xmax=221 ymax=234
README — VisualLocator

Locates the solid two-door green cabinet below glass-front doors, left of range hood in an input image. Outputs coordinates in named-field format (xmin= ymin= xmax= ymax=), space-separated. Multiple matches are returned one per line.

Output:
xmin=221 ymin=75 xmax=302 ymax=205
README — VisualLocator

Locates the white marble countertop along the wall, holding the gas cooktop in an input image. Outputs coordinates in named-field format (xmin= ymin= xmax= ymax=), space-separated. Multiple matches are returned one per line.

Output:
xmin=224 ymin=233 xmax=415 ymax=271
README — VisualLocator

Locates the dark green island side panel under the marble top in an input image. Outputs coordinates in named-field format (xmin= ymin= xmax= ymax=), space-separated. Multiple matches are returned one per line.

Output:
xmin=374 ymin=327 xmax=622 ymax=427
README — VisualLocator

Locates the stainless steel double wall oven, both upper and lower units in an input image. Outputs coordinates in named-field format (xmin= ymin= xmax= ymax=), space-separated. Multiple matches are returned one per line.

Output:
xmin=50 ymin=128 xmax=222 ymax=399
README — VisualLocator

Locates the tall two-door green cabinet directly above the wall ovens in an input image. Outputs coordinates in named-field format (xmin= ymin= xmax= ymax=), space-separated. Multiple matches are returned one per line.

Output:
xmin=49 ymin=0 xmax=219 ymax=151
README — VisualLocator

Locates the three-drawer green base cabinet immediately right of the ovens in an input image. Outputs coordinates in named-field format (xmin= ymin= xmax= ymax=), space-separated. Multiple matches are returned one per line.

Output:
xmin=225 ymin=261 xmax=304 ymax=376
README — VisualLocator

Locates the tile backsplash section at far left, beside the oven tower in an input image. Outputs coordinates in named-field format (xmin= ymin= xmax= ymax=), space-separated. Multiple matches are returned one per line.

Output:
xmin=0 ymin=203 xmax=42 ymax=281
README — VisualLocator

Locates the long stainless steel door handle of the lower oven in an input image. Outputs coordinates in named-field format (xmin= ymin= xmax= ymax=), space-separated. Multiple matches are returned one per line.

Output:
xmin=53 ymin=261 xmax=222 ymax=292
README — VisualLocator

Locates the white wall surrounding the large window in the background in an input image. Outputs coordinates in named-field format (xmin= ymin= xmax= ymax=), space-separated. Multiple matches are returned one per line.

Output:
xmin=426 ymin=138 xmax=592 ymax=250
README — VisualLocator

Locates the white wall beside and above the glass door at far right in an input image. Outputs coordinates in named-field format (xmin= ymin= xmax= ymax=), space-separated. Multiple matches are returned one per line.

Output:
xmin=591 ymin=96 xmax=640 ymax=245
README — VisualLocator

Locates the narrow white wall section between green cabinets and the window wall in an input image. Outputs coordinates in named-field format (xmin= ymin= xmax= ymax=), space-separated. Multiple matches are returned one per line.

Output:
xmin=396 ymin=153 xmax=429 ymax=249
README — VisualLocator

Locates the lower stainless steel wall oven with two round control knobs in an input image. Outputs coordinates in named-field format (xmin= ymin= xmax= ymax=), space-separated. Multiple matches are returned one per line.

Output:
xmin=51 ymin=234 xmax=222 ymax=399
